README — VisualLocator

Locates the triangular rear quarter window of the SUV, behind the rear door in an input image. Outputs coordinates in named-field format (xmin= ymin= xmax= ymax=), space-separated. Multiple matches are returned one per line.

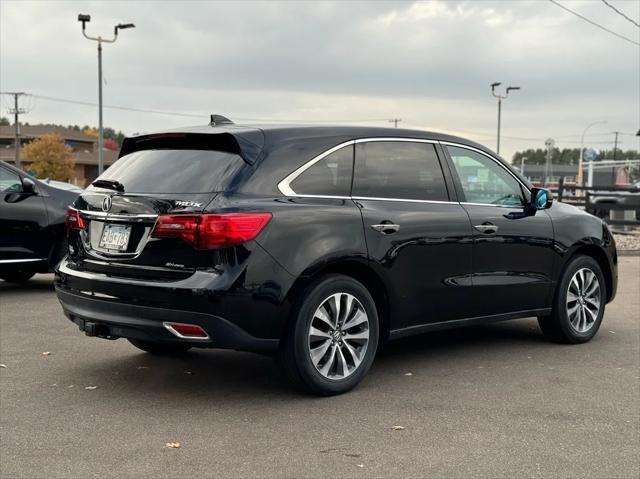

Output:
xmin=290 ymin=145 xmax=353 ymax=196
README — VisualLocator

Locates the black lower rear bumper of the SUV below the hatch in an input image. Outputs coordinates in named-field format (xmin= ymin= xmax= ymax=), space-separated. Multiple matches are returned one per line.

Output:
xmin=56 ymin=286 xmax=278 ymax=352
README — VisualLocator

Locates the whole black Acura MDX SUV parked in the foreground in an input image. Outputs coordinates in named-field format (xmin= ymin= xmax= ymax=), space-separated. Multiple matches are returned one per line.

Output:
xmin=56 ymin=121 xmax=617 ymax=395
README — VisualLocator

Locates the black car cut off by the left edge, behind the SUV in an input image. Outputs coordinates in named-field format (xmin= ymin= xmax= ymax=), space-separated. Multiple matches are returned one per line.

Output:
xmin=0 ymin=161 xmax=79 ymax=282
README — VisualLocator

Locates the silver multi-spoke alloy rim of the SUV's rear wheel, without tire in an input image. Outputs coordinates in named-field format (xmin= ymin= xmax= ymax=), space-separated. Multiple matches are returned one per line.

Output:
xmin=307 ymin=293 xmax=369 ymax=380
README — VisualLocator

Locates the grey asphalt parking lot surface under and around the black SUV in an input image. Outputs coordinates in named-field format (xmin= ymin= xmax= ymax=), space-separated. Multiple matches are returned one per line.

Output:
xmin=0 ymin=257 xmax=640 ymax=478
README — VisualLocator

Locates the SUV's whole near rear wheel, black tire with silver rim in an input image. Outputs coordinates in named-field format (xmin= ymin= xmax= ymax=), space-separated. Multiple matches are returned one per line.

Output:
xmin=278 ymin=274 xmax=379 ymax=396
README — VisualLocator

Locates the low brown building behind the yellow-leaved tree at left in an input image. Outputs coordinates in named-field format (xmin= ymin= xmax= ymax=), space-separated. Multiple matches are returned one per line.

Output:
xmin=0 ymin=125 xmax=118 ymax=187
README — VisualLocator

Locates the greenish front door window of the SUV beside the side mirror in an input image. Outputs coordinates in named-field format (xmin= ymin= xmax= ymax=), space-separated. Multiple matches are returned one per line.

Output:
xmin=447 ymin=146 xmax=525 ymax=206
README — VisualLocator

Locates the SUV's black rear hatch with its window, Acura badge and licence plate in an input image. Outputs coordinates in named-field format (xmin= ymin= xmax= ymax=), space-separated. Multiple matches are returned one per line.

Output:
xmin=70 ymin=133 xmax=247 ymax=280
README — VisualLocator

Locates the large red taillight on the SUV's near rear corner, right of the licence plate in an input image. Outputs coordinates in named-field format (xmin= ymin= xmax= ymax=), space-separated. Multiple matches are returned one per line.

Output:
xmin=151 ymin=213 xmax=271 ymax=249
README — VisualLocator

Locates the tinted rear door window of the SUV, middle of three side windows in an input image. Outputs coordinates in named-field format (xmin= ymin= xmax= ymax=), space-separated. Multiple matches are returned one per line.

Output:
xmin=353 ymin=141 xmax=449 ymax=201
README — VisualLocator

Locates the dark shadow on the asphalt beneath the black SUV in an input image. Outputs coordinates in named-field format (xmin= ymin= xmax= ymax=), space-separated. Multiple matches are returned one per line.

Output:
xmin=58 ymin=320 xmax=544 ymax=404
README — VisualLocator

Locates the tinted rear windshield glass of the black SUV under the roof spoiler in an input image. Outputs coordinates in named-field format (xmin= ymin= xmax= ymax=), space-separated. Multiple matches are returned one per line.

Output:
xmin=100 ymin=150 xmax=245 ymax=193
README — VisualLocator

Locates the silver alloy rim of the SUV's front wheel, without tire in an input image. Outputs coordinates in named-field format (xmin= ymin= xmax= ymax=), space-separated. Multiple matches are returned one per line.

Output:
xmin=566 ymin=268 xmax=601 ymax=333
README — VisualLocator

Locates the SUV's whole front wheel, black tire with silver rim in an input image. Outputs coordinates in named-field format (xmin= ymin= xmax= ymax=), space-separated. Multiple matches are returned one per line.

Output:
xmin=538 ymin=255 xmax=607 ymax=344
